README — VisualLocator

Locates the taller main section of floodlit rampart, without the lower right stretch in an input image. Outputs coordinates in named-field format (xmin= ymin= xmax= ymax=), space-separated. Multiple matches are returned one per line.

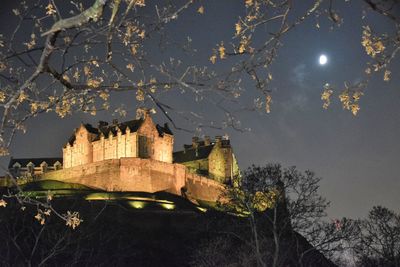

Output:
xmin=41 ymin=158 xmax=185 ymax=195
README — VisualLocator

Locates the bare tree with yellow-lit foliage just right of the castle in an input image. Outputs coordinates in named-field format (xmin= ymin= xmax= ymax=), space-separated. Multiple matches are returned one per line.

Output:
xmin=216 ymin=164 xmax=355 ymax=266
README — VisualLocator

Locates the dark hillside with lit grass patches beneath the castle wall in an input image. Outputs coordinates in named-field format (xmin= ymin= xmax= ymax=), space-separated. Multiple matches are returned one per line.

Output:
xmin=0 ymin=183 xmax=334 ymax=266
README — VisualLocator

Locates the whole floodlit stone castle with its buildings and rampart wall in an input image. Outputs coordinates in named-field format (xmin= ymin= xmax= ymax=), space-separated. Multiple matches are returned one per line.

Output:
xmin=9 ymin=110 xmax=239 ymax=202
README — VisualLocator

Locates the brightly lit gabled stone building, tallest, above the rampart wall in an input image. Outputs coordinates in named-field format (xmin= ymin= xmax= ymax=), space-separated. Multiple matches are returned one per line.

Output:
xmin=63 ymin=112 xmax=174 ymax=168
